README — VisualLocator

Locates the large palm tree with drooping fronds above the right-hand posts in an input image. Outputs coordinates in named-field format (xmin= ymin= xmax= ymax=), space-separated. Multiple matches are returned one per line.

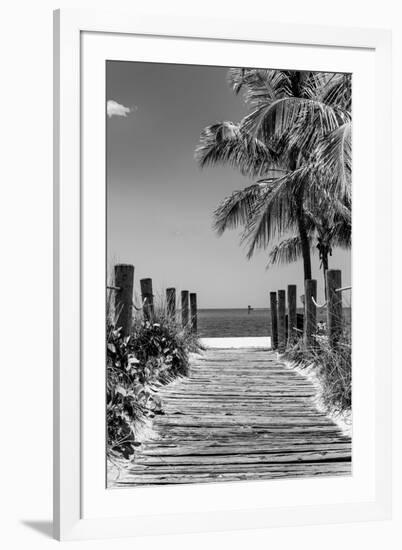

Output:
xmin=196 ymin=69 xmax=350 ymax=279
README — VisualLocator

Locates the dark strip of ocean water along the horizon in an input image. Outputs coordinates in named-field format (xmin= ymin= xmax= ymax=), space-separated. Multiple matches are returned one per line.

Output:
xmin=198 ymin=308 xmax=351 ymax=338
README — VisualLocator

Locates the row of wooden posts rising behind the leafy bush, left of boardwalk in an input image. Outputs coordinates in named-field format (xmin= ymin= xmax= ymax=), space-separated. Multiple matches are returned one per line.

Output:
xmin=112 ymin=264 xmax=197 ymax=336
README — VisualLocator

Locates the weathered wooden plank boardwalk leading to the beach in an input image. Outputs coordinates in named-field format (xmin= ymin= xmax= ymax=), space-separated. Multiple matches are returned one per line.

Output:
xmin=116 ymin=349 xmax=351 ymax=486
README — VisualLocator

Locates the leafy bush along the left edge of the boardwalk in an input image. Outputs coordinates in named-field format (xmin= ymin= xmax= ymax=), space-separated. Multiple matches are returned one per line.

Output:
xmin=106 ymin=307 xmax=199 ymax=463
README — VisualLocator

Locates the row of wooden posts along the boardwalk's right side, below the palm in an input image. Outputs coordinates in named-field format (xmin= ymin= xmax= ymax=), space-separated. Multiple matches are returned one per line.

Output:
xmin=270 ymin=269 xmax=343 ymax=352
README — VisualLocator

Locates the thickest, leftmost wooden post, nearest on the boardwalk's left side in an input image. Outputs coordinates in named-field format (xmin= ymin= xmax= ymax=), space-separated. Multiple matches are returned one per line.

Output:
xmin=114 ymin=264 xmax=134 ymax=336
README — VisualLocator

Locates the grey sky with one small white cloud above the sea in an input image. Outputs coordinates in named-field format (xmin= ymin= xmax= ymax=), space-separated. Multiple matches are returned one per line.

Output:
xmin=106 ymin=61 xmax=351 ymax=309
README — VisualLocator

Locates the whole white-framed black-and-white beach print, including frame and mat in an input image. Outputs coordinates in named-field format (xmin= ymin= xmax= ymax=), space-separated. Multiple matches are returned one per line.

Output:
xmin=54 ymin=10 xmax=391 ymax=540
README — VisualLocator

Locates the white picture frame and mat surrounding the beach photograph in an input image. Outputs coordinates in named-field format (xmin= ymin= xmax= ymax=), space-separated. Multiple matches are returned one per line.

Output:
xmin=54 ymin=10 xmax=391 ymax=540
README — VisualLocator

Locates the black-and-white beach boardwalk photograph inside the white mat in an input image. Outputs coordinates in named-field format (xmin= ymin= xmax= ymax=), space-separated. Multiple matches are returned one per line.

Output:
xmin=105 ymin=60 xmax=353 ymax=490
